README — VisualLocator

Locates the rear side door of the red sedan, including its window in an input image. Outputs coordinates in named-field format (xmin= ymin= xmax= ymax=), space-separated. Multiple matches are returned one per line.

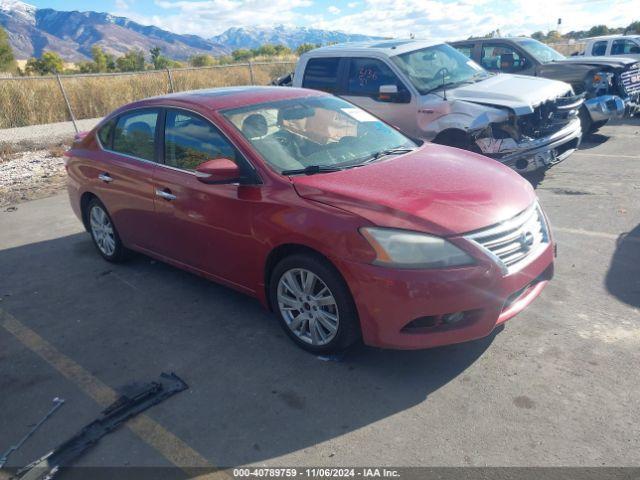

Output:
xmin=87 ymin=108 xmax=159 ymax=248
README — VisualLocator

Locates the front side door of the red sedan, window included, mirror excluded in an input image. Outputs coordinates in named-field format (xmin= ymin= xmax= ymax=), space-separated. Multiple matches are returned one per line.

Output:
xmin=153 ymin=108 xmax=260 ymax=285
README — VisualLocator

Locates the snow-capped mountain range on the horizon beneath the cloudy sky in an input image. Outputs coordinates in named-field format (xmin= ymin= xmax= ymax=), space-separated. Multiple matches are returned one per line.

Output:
xmin=0 ymin=0 xmax=380 ymax=61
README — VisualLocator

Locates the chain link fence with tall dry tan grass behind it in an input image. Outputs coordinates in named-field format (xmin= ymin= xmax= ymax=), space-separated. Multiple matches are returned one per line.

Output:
xmin=0 ymin=62 xmax=295 ymax=129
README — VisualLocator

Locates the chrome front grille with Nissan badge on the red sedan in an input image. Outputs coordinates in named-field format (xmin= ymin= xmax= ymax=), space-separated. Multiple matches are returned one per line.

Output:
xmin=466 ymin=203 xmax=549 ymax=273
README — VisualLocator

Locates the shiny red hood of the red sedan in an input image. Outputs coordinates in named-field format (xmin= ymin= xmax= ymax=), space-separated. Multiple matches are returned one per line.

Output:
xmin=292 ymin=143 xmax=535 ymax=236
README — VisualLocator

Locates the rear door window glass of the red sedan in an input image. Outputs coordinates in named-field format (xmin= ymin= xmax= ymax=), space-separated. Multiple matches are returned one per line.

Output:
xmin=113 ymin=110 xmax=158 ymax=161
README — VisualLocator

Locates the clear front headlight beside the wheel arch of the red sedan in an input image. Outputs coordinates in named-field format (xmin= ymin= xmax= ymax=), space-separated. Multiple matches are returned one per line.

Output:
xmin=360 ymin=227 xmax=475 ymax=268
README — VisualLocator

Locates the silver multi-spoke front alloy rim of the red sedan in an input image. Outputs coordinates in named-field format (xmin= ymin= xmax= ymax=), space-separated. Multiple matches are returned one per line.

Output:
xmin=277 ymin=268 xmax=340 ymax=346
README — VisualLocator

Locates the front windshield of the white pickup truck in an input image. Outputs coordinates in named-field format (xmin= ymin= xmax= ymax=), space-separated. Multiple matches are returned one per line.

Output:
xmin=392 ymin=44 xmax=489 ymax=95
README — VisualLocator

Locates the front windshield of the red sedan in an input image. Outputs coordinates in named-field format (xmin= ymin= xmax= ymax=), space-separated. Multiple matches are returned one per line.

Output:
xmin=222 ymin=96 xmax=417 ymax=173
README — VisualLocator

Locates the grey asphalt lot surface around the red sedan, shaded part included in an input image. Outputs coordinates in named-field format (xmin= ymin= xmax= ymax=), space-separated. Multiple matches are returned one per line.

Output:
xmin=0 ymin=120 xmax=640 ymax=472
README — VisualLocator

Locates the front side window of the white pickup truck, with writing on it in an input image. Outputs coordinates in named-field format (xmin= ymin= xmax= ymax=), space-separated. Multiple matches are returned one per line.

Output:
xmin=347 ymin=58 xmax=407 ymax=96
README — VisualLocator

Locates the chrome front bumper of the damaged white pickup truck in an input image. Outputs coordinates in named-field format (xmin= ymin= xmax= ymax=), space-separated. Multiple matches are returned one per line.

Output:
xmin=494 ymin=118 xmax=582 ymax=173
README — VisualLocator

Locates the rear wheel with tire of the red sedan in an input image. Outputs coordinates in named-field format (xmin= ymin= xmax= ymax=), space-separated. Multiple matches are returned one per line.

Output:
xmin=85 ymin=198 xmax=129 ymax=263
